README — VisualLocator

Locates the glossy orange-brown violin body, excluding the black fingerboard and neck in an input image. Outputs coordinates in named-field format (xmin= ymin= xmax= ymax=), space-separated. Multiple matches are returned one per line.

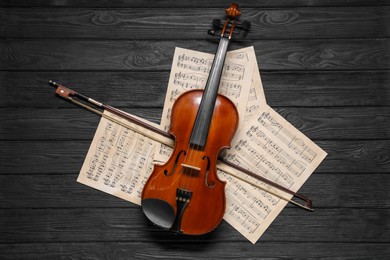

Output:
xmin=141 ymin=90 xmax=238 ymax=235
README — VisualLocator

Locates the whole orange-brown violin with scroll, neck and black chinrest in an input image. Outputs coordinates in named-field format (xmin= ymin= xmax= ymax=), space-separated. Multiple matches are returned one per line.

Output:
xmin=141 ymin=3 xmax=250 ymax=235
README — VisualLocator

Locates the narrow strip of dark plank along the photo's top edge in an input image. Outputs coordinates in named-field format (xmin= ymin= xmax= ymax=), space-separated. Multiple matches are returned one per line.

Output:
xmin=0 ymin=0 xmax=389 ymax=8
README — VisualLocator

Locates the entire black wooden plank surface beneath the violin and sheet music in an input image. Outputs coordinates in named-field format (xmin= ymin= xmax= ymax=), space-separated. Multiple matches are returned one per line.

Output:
xmin=0 ymin=0 xmax=390 ymax=259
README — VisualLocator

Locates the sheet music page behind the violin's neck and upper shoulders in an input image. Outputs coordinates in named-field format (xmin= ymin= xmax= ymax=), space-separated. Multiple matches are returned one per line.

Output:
xmin=160 ymin=47 xmax=256 ymax=131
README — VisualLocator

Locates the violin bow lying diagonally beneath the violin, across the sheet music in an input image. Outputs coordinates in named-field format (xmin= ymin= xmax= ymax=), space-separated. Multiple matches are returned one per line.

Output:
xmin=49 ymin=80 xmax=314 ymax=211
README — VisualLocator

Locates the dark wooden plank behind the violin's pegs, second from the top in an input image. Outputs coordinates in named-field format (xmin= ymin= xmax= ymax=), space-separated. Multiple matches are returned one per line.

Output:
xmin=0 ymin=7 xmax=390 ymax=40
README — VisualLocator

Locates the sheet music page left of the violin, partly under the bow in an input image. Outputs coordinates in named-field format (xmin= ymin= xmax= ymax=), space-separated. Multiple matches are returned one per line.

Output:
xmin=77 ymin=111 xmax=168 ymax=205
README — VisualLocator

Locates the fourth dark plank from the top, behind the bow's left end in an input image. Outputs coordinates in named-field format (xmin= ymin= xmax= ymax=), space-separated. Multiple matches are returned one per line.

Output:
xmin=0 ymin=70 xmax=390 ymax=108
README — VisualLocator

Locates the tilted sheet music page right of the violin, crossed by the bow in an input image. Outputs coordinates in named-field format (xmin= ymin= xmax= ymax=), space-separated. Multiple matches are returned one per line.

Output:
xmin=218 ymin=105 xmax=326 ymax=243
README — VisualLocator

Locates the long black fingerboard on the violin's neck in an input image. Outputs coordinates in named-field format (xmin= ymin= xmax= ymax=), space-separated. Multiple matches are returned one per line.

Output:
xmin=190 ymin=36 xmax=230 ymax=150
